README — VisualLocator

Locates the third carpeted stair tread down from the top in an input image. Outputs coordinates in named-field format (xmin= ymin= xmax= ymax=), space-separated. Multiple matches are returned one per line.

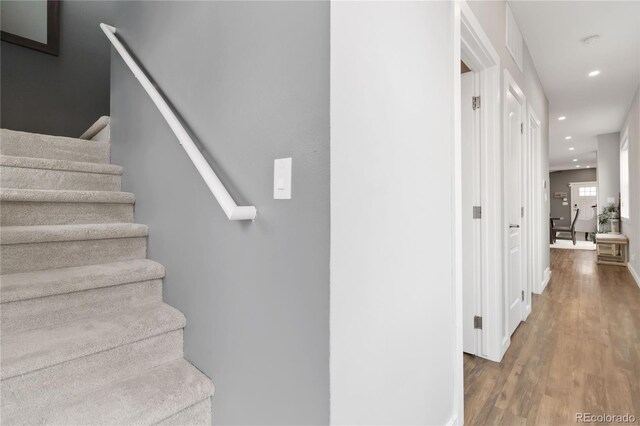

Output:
xmin=0 ymin=223 xmax=149 ymax=245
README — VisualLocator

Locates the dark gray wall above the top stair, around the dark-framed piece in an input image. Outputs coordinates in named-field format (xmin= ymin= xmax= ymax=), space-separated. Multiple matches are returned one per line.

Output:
xmin=0 ymin=0 xmax=113 ymax=137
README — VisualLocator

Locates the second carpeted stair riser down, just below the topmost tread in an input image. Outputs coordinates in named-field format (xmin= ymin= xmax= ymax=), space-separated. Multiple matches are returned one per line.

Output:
xmin=0 ymin=166 xmax=122 ymax=191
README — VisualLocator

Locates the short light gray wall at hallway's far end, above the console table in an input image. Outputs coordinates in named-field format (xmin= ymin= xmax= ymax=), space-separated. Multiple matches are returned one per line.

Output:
xmin=598 ymin=132 xmax=620 ymax=209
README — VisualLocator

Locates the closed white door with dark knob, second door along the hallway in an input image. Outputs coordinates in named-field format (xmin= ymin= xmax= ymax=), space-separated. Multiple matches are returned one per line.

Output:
xmin=505 ymin=85 xmax=523 ymax=335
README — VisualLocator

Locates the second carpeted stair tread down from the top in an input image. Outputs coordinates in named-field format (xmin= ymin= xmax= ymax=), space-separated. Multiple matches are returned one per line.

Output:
xmin=0 ymin=188 xmax=136 ymax=204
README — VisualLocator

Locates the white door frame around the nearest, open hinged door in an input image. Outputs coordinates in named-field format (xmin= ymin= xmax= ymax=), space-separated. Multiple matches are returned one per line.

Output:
xmin=448 ymin=0 xmax=504 ymax=424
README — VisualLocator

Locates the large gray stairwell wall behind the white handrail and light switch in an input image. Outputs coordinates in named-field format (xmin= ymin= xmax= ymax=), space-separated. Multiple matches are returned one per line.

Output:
xmin=111 ymin=2 xmax=329 ymax=424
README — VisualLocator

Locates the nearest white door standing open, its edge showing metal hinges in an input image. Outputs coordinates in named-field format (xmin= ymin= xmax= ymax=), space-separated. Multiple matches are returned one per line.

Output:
xmin=461 ymin=72 xmax=481 ymax=355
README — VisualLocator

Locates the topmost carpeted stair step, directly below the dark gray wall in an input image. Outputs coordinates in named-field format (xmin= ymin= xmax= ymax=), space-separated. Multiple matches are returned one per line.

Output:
xmin=0 ymin=129 xmax=110 ymax=163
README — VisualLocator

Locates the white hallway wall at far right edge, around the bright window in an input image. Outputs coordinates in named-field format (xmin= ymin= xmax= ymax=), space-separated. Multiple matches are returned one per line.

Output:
xmin=620 ymin=88 xmax=640 ymax=285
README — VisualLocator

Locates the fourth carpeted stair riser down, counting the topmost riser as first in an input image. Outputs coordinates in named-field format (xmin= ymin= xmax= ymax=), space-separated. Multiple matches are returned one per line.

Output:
xmin=0 ymin=237 xmax=147 ymax=274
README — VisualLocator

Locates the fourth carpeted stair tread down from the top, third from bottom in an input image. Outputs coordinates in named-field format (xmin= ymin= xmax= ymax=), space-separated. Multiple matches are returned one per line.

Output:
xmin=0 ymin=259 xmax=165 ymax=303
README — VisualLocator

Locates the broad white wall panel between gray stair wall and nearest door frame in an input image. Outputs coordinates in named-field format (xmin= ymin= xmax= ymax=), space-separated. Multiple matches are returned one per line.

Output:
xmin=330 ymin=1 xmax=455 ymax=425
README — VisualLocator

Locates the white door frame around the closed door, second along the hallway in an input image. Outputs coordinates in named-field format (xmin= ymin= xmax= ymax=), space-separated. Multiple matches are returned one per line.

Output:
xmin=502 ymin=68 xmax=531 ymax=340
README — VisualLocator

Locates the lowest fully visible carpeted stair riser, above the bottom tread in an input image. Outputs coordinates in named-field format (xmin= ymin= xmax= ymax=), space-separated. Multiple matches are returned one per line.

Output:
xmin=0 ymin=330 xmax=183 ymax=424
